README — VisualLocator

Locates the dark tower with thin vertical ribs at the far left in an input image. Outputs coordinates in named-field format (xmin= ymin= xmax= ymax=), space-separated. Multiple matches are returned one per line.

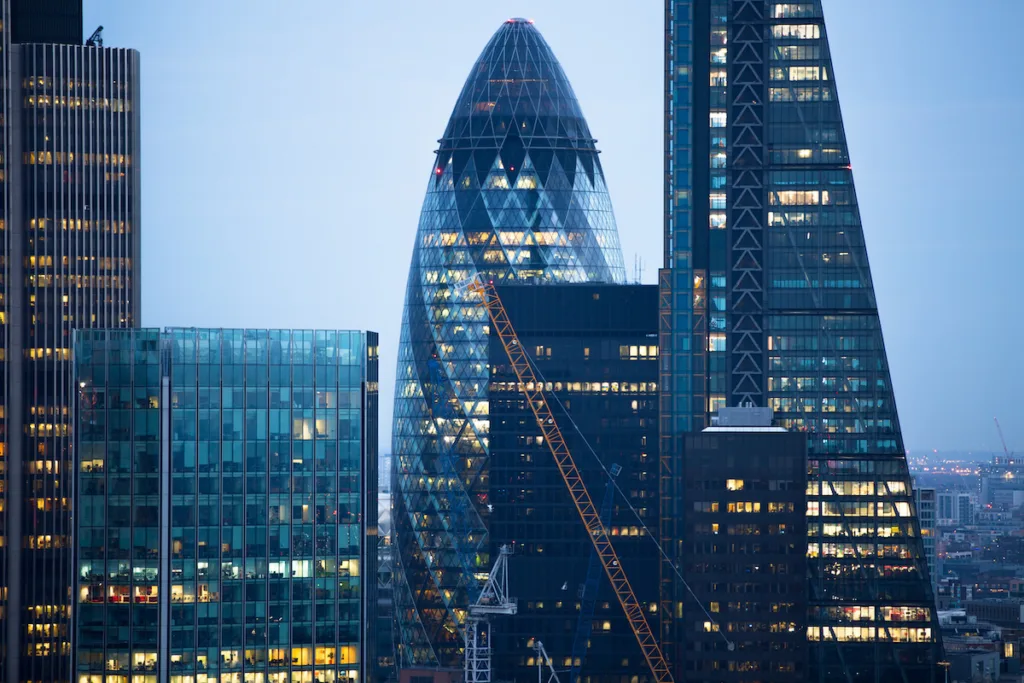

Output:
xmin=0 ymin=0 xmax=139 ymax=683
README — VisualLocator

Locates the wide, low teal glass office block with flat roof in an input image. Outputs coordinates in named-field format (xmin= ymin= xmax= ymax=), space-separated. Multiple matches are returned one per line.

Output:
xmin=73 ymin=329 xmax=378 ymax=683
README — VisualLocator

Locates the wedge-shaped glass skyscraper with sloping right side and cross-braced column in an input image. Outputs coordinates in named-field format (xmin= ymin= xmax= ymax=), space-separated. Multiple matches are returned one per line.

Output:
xmin=659 ymin=0 xmax=941 ymax=682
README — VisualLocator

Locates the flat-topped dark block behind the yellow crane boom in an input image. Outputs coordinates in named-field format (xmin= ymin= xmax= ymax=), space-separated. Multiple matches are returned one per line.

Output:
xmin=487 ymin=285 xmax=658 ymax=683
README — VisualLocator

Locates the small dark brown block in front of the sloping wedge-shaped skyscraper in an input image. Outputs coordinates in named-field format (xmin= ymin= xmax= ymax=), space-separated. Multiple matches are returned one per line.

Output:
xmin=674 ymin=423 xmax=808 ymax=683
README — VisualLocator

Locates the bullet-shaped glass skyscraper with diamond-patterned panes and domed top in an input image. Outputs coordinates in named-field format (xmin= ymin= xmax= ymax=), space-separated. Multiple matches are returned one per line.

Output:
xmin=392 ymin=18 xmax=624 ymax=667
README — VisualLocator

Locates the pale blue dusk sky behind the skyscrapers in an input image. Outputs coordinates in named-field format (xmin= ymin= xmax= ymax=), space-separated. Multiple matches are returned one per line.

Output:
xmin=85 ymin=0 xmax=1024 ymax=453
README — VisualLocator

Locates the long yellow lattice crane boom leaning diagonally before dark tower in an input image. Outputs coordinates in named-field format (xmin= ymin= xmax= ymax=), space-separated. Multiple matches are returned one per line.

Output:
xmin=466 ymin=279 xmax=673 ymax=683
